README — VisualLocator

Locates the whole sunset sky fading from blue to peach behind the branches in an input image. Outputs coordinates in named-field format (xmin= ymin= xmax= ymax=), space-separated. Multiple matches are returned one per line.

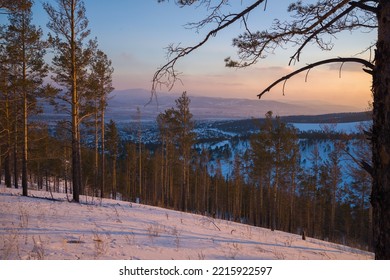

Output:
xmin=12 ymin=0 xmax=376 ymax=110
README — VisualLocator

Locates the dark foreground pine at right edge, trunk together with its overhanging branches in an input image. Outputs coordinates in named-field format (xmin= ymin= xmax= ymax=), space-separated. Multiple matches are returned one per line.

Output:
xmin=152 ymin=0 xmax=390 ymax=259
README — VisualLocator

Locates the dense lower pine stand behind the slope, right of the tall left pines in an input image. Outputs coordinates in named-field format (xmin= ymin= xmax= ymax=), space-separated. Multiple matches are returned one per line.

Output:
xmin=112 ymin=92 xmax=372 ymax=249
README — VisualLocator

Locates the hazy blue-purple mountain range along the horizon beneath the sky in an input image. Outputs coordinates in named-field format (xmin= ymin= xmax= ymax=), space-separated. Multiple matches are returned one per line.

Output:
xmin=107 ymin=89 xmax=359 ymax=122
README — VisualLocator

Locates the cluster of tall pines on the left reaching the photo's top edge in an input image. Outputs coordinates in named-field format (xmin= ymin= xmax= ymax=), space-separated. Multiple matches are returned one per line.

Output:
xmin=0 ymin=0 xmax=113 ymax=202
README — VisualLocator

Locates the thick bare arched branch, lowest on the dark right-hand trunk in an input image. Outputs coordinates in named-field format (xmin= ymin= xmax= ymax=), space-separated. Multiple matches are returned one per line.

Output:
xmin=257 ymin=57 xmax=374 ymax=99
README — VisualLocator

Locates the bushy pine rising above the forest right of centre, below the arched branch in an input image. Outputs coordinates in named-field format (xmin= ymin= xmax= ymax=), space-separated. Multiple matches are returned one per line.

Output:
xmin=249 ymin=112 xmax=299 ymax=230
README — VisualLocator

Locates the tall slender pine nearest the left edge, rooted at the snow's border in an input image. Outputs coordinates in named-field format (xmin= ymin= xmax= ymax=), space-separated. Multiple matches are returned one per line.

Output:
xmin=5 ymin=0 xmax=48 ymax=196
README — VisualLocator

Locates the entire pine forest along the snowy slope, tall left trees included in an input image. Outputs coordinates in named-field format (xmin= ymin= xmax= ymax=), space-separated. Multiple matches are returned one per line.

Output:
xmin=0 ymin=0 xmax=372 ymax=248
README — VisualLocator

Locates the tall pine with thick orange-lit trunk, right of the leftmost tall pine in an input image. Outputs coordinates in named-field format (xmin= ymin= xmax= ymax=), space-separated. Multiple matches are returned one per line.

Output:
xmin=44 ymin=0 xmax=96 ymax=202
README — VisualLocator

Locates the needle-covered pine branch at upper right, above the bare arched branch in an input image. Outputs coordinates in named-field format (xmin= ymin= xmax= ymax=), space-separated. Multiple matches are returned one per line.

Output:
xmin=225 ymin=0 xmax=377 ymax=68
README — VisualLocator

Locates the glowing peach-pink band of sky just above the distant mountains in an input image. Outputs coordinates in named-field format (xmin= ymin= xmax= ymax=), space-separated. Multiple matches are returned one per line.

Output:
xmin=115 ymin=60 xmax=372 ymax=110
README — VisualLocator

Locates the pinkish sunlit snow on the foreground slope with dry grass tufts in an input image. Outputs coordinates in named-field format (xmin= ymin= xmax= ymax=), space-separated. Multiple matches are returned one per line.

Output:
xmin=0 ymin=186 xmax=374 ymax=260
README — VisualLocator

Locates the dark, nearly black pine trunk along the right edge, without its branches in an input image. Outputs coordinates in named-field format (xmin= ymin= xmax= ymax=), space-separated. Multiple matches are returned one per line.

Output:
xmin=371 ymin=0 xmax=390 ymax=260
